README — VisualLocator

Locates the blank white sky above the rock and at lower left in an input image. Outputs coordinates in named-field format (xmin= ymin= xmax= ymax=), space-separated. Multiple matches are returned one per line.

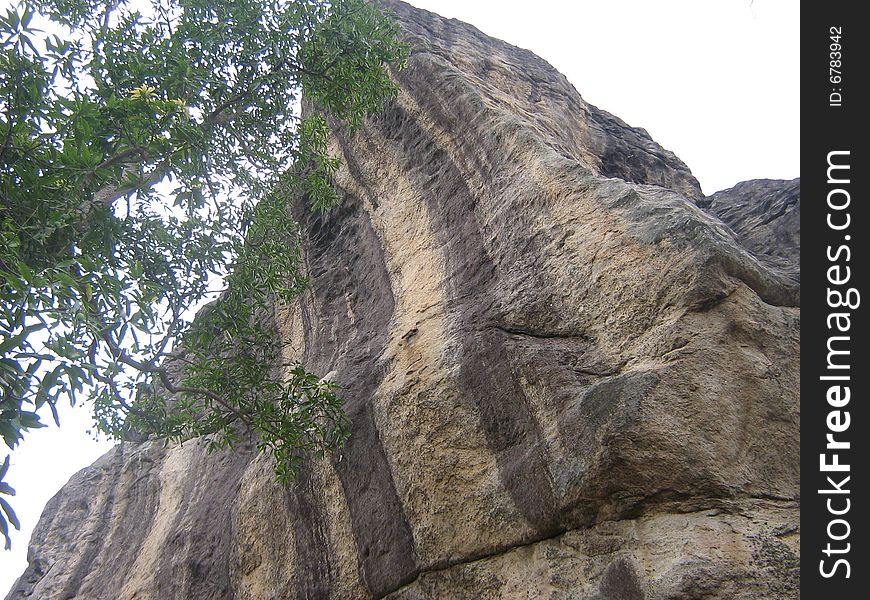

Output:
xmin=0 ymin=0 xmax=800 ymax=597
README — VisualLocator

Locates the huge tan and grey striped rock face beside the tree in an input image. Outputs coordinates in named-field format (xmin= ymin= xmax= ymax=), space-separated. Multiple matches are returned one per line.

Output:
xmin=8 ymin=2 xmax=800 ymax=600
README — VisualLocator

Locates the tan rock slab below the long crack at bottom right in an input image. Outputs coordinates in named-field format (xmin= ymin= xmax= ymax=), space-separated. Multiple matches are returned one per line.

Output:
xmin=388 ymin=502 xmax=800 ymax=600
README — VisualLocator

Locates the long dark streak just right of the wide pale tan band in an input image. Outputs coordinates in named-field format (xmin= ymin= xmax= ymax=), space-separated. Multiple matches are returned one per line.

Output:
xmin=368 ymin=98 xmax=559 ymax=533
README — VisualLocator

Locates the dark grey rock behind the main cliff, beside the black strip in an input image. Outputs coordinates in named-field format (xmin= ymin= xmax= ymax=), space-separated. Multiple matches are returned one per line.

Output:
xmin=698 ymin=179 xmax=801 ymax=281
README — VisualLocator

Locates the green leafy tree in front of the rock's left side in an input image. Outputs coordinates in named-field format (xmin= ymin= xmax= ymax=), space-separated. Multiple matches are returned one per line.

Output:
xmin=0 ymin=0 xmax=406 ymax=547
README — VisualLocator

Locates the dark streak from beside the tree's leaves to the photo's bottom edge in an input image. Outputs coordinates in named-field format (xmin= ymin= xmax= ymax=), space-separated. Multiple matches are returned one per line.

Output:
xmin=300 ymin=193 xmax=417 ymax=596
